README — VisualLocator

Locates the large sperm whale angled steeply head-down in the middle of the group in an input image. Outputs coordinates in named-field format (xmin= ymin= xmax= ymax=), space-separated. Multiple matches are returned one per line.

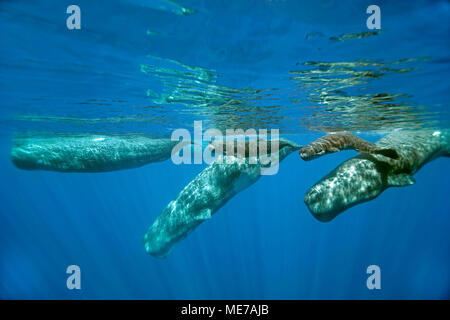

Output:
xmin=144 ymin=139 xmax=301 ymax=258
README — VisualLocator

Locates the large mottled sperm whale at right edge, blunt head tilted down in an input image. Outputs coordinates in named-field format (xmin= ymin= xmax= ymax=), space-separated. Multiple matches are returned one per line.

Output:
xmin=304 ymin=129 xmax=450 ymax=222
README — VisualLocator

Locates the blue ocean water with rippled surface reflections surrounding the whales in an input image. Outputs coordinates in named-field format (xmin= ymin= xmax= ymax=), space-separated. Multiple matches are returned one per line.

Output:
xmin=0 ymin=0 xmax=450 ymax=299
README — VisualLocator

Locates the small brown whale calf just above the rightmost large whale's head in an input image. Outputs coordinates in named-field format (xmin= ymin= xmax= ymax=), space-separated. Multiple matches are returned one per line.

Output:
xmin=299 ymin=133 xmax=399 ymax=161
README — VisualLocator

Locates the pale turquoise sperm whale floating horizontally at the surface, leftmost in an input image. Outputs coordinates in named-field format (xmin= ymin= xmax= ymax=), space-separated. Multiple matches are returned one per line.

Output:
xmin=11 ymin=134 xmax=189 ymax=172
